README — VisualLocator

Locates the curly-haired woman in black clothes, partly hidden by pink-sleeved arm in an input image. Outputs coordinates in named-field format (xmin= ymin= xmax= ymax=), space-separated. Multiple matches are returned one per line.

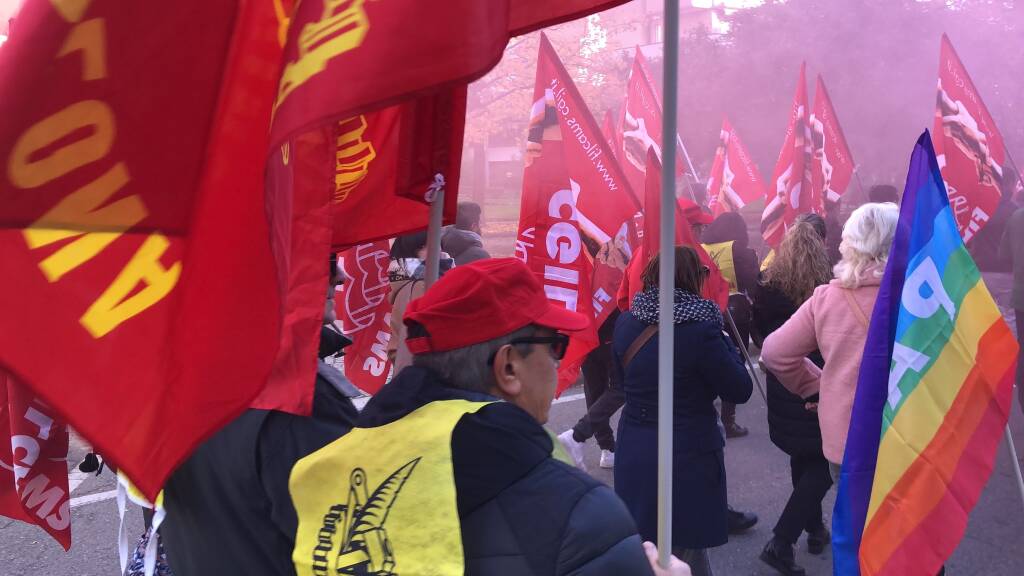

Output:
xmin=754 ymin=218 xmax=831 ymax=576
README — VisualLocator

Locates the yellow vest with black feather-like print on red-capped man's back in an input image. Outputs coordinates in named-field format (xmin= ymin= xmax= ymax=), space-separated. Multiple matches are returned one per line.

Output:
xmin=289 ymin=400 xmax=487 ymax=576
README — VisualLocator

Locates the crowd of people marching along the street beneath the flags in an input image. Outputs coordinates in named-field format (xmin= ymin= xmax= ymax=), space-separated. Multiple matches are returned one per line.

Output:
xmin=138 ymin=190 xmax=1024 ymax=576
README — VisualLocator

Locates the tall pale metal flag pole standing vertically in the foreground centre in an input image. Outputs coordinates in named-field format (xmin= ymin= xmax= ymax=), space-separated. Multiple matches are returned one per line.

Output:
xmin=657 ymin=0 xmax=679 ymax=569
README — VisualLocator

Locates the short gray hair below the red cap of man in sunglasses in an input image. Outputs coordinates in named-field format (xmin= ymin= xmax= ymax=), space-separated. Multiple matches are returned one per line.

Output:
xmin=413 ymin=325 xmax=537 ymax=394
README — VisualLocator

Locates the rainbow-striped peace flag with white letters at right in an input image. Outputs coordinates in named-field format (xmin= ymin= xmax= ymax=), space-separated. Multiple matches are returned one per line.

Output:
xmin=833 ymin=131 xmax=1017 ymax=576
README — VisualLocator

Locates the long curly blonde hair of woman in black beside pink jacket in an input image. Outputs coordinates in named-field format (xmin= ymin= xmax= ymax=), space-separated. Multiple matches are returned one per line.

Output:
xmin=764 ymin=220 xmax=833 ymax=305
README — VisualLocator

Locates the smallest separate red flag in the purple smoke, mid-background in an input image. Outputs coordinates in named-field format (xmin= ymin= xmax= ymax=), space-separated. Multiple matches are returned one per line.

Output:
xmin=708 ymin=118 xmax=765 ymax=217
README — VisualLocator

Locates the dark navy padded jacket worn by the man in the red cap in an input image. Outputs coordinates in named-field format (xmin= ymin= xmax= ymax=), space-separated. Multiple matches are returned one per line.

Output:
xmin=358 ymin=366 xmax=651 ymax=576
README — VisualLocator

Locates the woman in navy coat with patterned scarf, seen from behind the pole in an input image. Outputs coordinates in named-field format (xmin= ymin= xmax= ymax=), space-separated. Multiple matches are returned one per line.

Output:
xmin=611 ymin=246 xmax=753 ymax=576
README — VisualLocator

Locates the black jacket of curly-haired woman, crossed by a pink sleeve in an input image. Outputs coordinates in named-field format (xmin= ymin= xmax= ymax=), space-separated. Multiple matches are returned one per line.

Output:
xmin=754 ymin=285 xmax=824 ymax=456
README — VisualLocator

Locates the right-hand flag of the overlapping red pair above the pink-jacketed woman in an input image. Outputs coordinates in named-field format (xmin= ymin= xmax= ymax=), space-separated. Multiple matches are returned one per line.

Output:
xmin=810 ymin=76 xmax=856 ymax=215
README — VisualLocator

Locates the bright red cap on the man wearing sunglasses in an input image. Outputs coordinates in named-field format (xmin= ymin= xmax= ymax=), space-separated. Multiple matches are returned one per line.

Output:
xmin=402 ymin=258 xmax=590 ymax=354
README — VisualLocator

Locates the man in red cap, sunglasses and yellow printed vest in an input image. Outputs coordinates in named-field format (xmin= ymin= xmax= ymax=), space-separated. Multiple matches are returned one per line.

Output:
xmin=291 ymin=258 xmax=689 ymax=576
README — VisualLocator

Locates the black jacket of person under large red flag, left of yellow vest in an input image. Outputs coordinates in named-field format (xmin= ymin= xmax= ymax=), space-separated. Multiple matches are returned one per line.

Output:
xmin=160 ymin=375 xmax=357 ymax=576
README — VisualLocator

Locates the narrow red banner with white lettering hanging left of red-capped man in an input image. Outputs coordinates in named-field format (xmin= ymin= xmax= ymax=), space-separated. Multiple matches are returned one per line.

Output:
xmin=337 ymin=240 xmax=391 ymax=395
